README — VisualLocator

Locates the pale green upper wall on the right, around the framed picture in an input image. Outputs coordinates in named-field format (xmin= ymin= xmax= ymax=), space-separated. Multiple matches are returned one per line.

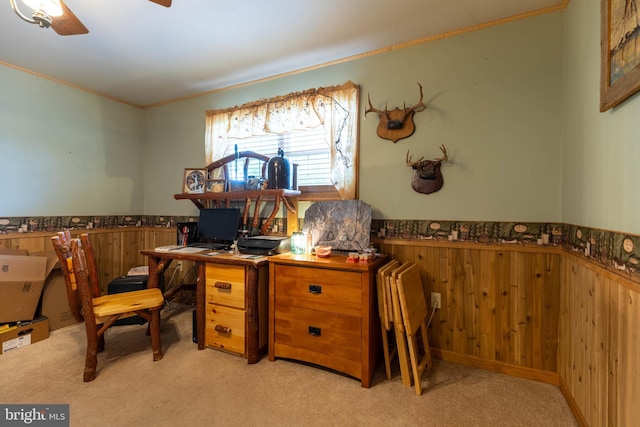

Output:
xmin=562 ymin=1 xmax=640 ymax=234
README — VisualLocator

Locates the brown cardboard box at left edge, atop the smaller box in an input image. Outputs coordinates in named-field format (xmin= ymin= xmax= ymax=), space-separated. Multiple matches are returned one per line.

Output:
xmin=0 ymin=249 xmax=56 ymax=324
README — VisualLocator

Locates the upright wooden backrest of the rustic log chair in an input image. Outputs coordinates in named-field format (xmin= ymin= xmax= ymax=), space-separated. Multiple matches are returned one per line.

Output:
xmin=51 ymin=230 xmax=100 ymax=322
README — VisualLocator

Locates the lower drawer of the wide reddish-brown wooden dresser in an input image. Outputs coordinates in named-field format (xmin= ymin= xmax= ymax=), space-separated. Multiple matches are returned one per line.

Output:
xmin=275 ymin=306 xmax=362 ymax=362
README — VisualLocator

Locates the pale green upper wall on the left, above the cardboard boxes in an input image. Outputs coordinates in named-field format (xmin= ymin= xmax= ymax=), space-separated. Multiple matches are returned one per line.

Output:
xmin=0 ymin=66 xmax=144 ymax=217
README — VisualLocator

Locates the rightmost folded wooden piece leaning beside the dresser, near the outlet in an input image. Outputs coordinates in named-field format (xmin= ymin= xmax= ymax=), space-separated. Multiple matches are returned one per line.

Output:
xmin=397 ymin=264 xmax=431 ymax=395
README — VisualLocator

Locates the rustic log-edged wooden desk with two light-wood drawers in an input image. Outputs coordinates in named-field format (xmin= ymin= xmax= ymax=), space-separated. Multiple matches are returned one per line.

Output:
xmin=140 ymin=250 xmax=269 ymax=363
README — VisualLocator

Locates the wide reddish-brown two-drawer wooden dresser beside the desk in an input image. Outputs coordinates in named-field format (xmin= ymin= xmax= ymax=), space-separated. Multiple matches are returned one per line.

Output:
xmin=269 ymin=254 xmax=387 ymax=388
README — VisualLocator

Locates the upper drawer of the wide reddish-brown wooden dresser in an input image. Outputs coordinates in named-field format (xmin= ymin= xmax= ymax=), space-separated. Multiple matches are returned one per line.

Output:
xmin=275 ymin=265 xmax=362 ymax=317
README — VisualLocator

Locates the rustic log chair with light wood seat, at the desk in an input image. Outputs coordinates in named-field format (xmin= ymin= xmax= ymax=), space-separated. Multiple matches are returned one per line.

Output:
xmin=51 ymin=231 xmax=164 ymax=381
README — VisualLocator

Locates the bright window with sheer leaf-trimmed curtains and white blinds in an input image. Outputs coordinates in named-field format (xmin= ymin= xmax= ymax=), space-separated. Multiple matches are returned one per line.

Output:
xmin=205 ymin=82 xmax=358 ymax=200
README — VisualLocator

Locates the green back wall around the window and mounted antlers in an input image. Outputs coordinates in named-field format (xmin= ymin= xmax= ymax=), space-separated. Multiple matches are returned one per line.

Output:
xmin=145 ymin=13 xmax=563 ymax=221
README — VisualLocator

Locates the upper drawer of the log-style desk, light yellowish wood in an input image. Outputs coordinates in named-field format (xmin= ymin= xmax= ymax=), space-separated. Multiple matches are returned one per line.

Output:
xmin=206 ymin=264 xmax=245 ymax=309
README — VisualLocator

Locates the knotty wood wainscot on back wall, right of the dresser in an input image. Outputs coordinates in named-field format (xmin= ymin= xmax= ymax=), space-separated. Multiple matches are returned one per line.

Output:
xmin=381 ymin=243 xmax=562 ymax=372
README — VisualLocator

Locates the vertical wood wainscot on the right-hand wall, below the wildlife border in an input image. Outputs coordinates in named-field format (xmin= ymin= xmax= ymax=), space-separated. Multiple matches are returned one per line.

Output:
xmin=558 ymin=254 xmax=640 ymax=426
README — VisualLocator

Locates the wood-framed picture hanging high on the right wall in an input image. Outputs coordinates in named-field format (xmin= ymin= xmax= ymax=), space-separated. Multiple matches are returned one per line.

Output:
xmin=600 ymin=0 xmax=640 ymax=111
